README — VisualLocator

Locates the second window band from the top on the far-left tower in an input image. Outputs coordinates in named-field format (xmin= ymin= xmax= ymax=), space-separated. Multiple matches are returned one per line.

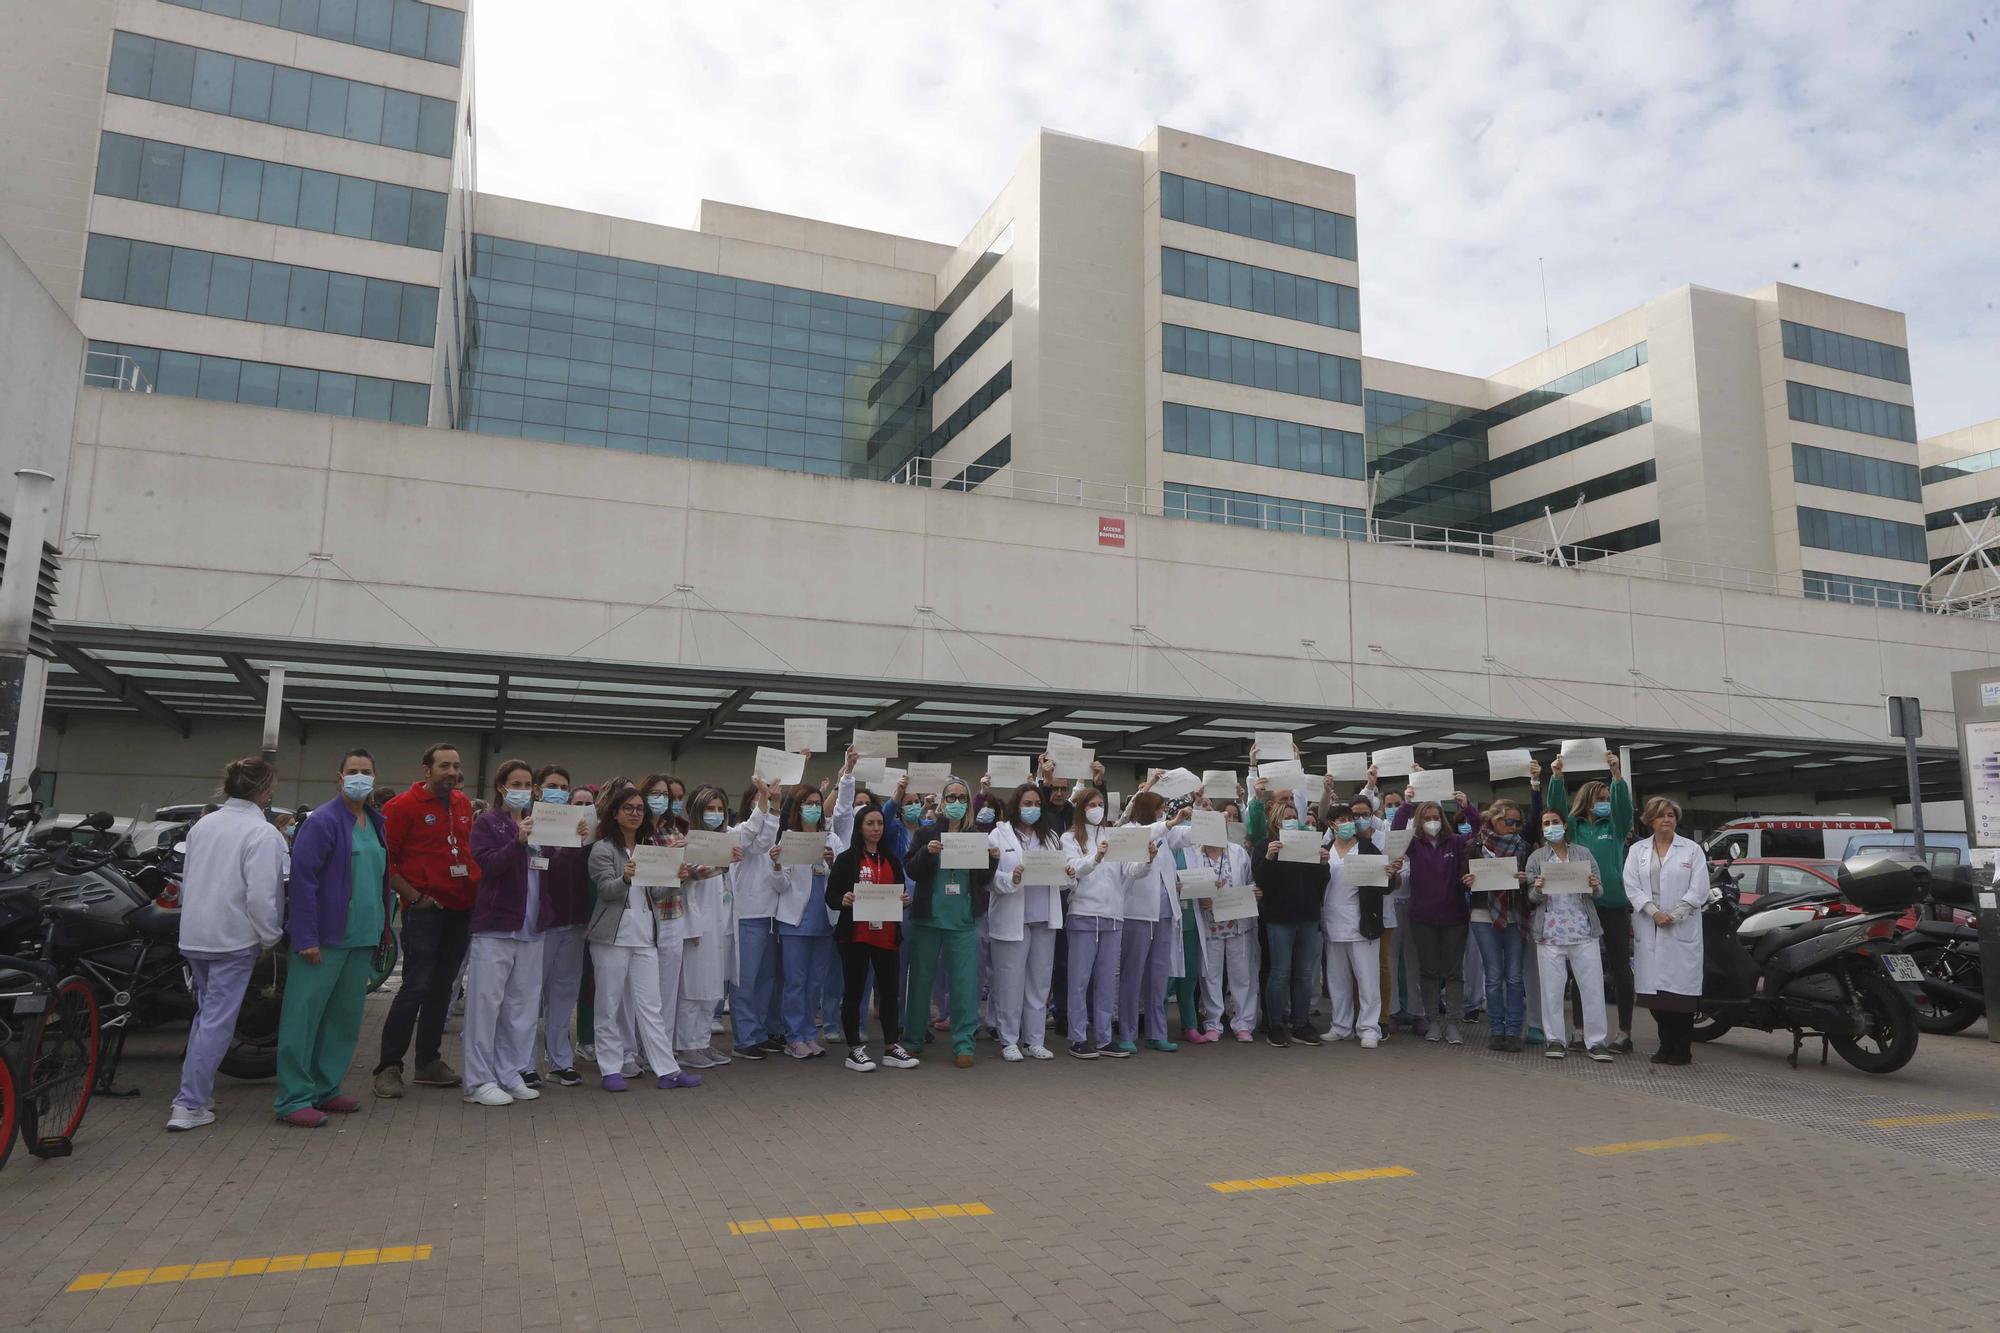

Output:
xmin=106 ymin=32 xmax=458 ymax=158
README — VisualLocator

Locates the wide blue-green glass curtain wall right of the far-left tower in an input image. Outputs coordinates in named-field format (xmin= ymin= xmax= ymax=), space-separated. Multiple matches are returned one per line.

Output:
xmin=456 ymin=236 xmax=932 ymax=478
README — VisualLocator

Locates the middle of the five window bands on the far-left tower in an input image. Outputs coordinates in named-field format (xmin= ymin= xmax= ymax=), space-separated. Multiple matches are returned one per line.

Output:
xmin=96 ymin=130 xmax=446 ymax=250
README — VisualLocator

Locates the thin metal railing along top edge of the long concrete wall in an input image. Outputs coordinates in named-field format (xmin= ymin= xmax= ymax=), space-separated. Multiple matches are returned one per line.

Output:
xmin=888 ymin=458 xmax=1952 ymax=620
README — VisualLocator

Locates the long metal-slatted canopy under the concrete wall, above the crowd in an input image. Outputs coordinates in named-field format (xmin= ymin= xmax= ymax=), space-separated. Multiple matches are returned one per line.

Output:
xmin=46 ymin=622 xmax=1960 ymax=801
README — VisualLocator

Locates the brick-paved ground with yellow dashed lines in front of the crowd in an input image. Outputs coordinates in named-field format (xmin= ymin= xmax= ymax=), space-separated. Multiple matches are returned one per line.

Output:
xmin=0 ymin=995 xmax=2000 ymax=1333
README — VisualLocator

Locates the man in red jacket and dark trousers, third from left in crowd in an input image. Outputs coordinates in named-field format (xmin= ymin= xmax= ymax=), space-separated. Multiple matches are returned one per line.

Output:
xmin=374 ymin=743 xmax=480 ymax=1097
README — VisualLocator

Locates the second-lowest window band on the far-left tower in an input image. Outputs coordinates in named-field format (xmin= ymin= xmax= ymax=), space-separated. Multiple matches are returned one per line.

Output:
xmin=84 ymin=232 xmax=438 ymax=346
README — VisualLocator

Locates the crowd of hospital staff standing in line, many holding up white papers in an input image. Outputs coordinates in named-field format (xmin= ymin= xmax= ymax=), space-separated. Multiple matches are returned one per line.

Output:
xmin=168 ymin=745 xmax=1708 ymax=1131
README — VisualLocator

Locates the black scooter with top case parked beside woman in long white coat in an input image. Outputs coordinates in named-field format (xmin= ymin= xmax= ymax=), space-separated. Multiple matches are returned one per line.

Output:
xmin=1694 ymin=853 xmax=1930 ymax=1073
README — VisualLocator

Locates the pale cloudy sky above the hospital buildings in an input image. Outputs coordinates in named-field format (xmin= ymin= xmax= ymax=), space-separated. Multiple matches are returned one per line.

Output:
xmin=476 ymin=0 xmax=2000 ymax=434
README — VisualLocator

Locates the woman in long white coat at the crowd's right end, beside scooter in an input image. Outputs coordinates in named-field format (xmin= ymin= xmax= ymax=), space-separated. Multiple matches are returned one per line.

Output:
xmin=1624 ymin=797 xmax=1708 ymax=1065
